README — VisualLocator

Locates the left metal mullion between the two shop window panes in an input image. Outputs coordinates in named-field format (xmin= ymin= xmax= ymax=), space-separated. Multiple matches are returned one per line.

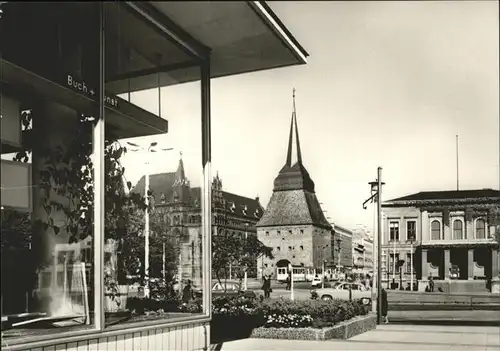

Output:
xmin=93 ymin=3 xmax=105 ymax=330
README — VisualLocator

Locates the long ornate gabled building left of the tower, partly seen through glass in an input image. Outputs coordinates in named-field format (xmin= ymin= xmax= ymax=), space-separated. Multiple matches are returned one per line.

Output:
xmin=133 ymin=158 xmax=264 ymax=282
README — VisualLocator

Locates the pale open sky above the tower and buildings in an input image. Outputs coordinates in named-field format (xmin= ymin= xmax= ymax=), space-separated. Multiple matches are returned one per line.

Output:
xmin=119 ymin=1 xmax=500 ymax=234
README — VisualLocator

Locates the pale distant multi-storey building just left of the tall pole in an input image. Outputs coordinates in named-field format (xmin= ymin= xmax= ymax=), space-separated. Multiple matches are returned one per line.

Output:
xmin=352 ymin=226 xmax=373 ymax=274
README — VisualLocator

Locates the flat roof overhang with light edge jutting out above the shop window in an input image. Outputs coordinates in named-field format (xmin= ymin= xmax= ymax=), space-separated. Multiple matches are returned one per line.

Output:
xmin=107 ymin=1 xmax=309 ymax=94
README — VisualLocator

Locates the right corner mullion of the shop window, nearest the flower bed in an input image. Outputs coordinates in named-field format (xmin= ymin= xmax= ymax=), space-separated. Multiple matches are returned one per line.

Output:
xmin=201 ymin=59 xmax=212 ymax=317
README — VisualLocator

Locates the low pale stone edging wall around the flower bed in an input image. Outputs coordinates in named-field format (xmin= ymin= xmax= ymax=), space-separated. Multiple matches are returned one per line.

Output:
xmin=250 ymin=314 xmax=377 ymax=340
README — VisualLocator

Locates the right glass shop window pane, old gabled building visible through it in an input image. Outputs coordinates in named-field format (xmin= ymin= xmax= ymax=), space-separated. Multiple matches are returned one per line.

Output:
xmin=104 ymin=5 xmax=204 ymax=326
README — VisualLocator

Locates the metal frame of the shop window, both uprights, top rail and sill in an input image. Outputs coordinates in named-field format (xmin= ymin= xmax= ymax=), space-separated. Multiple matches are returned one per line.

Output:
xmin=5 ymin=2 xmax=212 ymax=349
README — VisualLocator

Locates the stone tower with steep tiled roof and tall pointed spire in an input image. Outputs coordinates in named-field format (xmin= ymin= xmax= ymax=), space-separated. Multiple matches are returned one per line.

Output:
xmin=256 ymin=94 xmax=332 ymax=279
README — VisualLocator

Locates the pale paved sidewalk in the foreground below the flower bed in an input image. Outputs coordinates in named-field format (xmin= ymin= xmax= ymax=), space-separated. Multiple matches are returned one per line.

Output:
xmin=211 ymin=324 xmax=500 ymax=351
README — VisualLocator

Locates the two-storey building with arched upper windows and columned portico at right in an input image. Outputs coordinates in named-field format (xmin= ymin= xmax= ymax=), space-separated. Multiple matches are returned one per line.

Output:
xmin=382 ymin=189 xmax=500 ymax=292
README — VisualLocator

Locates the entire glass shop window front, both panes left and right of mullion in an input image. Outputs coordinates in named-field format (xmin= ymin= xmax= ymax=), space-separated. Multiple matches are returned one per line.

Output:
xmin=0 ymin=2 xmax=204 ymax=344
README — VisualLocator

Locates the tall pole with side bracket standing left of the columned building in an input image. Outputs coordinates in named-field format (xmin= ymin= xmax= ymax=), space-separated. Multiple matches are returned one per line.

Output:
xmin=363 ymin=167 xmax=385 ymax=324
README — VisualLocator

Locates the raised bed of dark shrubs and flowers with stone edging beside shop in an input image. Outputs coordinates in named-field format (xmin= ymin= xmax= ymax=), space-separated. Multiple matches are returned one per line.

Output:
xmin=210 ymin=297 xmax=373 ymax=341
